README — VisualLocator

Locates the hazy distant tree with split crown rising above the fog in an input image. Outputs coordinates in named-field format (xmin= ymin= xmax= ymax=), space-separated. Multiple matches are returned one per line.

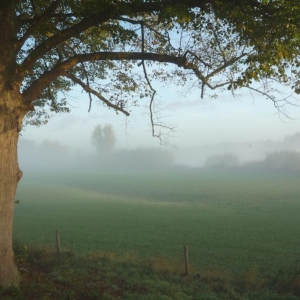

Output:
xmin=92 ymin=124 xmax=116 ymax=154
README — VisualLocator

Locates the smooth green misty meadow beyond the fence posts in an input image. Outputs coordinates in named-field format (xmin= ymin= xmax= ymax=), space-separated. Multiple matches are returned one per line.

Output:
xmin=14 ymin=170 xmax=300 ymax=274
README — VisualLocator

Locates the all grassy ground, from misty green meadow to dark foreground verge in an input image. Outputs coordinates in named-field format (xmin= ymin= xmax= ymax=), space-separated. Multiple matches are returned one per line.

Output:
xmin=0 ymin=171 xmax=300 ymax=300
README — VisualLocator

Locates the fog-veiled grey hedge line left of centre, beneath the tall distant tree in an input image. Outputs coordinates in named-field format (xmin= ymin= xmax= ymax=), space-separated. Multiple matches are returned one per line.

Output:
xmin=18 ymin=138 xmax=175 ymax=175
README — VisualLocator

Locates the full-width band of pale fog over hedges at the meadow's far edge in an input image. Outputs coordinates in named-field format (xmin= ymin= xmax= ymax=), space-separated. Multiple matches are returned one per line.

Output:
xmin=18 ymin=132 xmax=300 ymax=176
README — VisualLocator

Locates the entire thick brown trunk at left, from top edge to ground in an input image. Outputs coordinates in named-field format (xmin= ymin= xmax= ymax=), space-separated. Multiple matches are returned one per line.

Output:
xmin=0 ymin=0 xmax=29 ymax=287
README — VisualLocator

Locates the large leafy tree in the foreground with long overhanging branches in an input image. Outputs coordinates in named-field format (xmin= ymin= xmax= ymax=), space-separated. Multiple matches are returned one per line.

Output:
xmin=0 ymin=0 xmax=300 ymax=286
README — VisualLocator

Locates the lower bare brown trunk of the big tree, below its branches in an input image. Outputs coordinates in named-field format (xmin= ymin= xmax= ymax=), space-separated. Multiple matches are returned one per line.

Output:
xmin=0 ymin=106 xmax=24 ymax=287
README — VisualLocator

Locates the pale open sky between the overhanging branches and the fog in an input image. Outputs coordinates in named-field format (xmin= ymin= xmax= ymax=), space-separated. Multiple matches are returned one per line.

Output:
xmin=22 ymin=82 xmax=300 ymax=159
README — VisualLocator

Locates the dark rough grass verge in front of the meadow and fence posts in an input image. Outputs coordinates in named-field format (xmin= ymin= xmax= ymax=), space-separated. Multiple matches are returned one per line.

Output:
xmin=0 ymin=243 xmax=300 ymax=300
